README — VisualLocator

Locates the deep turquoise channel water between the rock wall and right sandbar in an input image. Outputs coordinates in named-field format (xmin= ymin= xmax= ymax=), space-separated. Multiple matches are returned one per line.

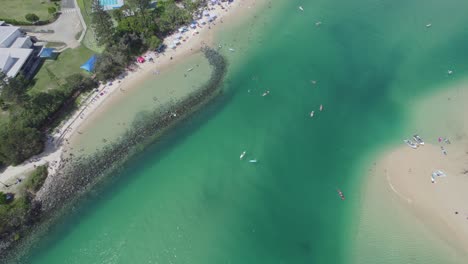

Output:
xmin=14 ymin=0 xmax=468 ymax=264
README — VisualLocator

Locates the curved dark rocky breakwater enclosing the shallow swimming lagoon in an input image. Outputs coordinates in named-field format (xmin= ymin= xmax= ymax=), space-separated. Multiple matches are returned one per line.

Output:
xmin=0 ymin=46 xmax=227 ymax=259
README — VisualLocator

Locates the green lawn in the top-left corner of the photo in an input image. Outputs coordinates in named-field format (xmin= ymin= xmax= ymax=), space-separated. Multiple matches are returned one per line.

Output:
xmin=0 ymin=0 xmax=54 ymax=21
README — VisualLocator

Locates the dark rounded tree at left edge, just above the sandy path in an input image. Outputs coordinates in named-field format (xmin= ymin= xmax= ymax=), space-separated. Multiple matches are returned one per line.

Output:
xmin=0 ymin=122 xmax=44 ymax=165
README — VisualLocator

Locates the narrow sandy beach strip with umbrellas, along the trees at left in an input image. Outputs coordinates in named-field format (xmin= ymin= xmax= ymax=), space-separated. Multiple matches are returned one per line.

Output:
xmin=0 ymin=0 xmax=263 ymax=191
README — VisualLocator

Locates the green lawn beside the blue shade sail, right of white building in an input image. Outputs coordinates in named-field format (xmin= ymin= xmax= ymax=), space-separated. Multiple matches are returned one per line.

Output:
xmin=29 ymin=45 xmax=94 ymax=94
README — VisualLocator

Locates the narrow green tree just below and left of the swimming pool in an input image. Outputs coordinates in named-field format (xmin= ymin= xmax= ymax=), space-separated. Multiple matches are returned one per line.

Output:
xmin=91 ymin=0 xmax=115 ymax=45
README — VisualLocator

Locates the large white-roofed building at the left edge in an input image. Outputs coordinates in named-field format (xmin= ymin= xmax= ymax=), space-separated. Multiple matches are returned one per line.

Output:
xmin=0 ymin=21 xmax=33 ymax=78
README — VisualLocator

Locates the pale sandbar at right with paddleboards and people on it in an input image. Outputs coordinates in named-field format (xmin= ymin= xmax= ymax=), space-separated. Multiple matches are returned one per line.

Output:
xmin=362 ymin=81 xmax=468 ymax=256
